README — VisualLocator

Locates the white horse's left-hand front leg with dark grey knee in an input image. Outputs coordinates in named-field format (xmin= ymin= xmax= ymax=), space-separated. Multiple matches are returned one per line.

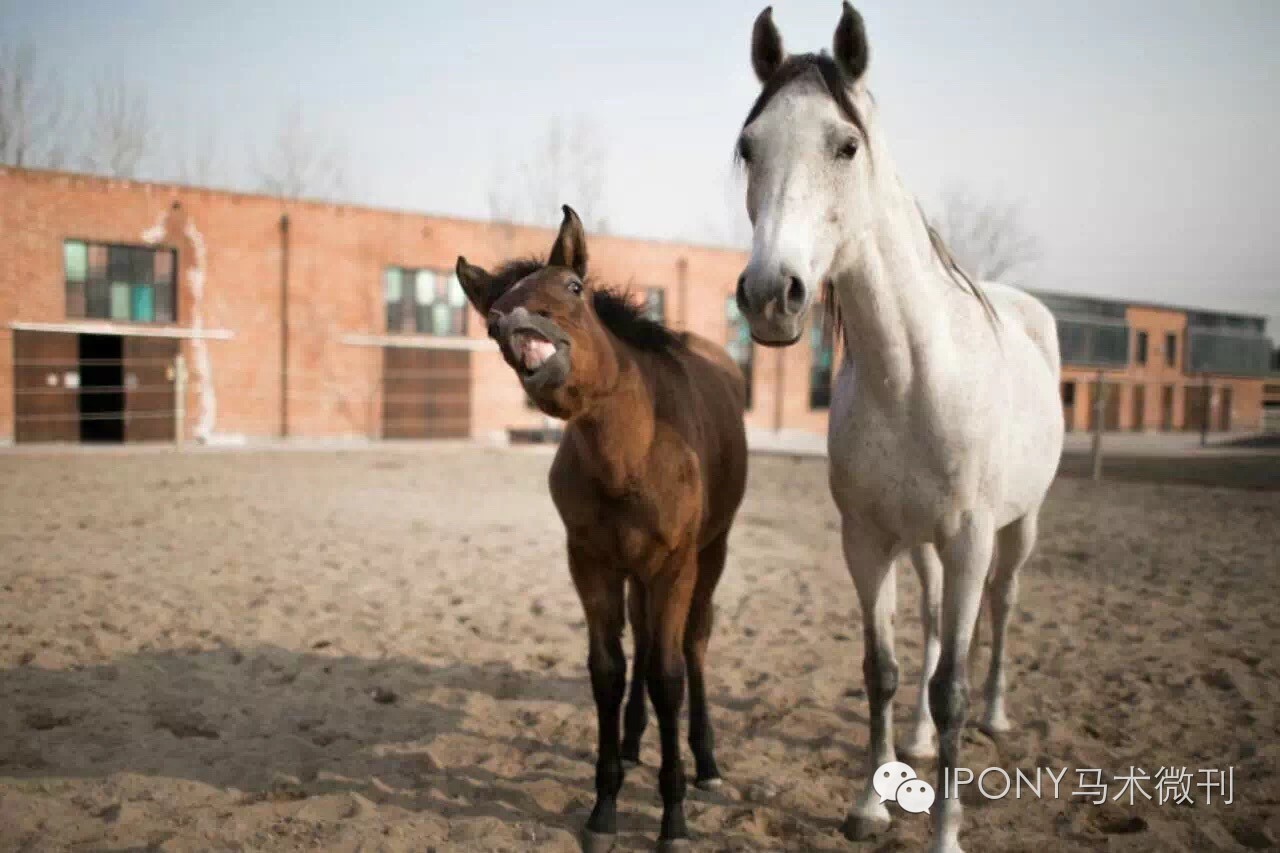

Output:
xmin=842 ymin=519 xmax=897 ymax=840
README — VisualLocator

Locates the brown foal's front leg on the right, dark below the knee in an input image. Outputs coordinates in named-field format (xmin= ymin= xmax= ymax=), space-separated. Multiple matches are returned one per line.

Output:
xmin=649 ymin=566 xmax=695 ymax=850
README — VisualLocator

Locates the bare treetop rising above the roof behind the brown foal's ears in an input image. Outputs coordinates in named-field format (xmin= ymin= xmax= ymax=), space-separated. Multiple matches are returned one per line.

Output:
xmin=489 ymin=117 xmax=608 ymax=233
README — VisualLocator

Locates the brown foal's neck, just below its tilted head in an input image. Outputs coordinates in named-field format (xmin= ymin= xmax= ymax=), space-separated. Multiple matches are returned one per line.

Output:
xmin=573 ymin=334 xmax=657 ymax=491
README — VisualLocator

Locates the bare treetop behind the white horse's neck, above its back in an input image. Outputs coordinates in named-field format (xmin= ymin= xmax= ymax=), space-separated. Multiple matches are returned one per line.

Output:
xmin=937 ymin=187 xmax=1041 ymax=284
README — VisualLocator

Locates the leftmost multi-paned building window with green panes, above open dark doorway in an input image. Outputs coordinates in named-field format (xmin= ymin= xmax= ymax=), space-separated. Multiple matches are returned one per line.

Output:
xmin=63 ymin=240 xmax=178 ymax=323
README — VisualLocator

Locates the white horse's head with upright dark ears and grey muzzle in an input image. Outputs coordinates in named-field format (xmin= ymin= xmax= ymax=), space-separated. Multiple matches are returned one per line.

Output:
xmin=737 ymin=3 xmax=874 ymax=346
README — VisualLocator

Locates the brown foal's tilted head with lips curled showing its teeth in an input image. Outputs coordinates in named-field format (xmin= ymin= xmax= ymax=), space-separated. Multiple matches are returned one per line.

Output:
xmin=457 ymin=205 xmax=617 ymax=418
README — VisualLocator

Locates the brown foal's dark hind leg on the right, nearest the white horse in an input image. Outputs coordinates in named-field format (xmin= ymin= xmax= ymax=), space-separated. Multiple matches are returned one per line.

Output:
xmin=685 ymin=534 xmax=728 ymax=788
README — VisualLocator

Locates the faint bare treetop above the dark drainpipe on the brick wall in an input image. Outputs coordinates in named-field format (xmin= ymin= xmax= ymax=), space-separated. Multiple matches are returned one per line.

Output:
xmin=255 ymin=101 xmax=347 ymax=200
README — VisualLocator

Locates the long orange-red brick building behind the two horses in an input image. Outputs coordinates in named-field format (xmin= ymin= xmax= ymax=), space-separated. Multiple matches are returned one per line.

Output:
xmin=0 ymin=168 xmax=1270 ymax=442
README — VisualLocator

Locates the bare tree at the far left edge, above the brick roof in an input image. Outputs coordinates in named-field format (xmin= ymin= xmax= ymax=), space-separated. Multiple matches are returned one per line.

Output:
xmin=0 ymin=44 xmax=68 ymax=169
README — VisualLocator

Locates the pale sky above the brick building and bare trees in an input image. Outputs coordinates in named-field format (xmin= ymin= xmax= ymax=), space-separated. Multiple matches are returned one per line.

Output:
xmin=0 ymin=0 xmax=1280 ymax=339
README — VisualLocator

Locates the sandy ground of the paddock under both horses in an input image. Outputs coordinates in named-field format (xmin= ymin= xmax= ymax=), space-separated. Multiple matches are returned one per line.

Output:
xmin=0 ymin=447 xmax=1280 ymax=853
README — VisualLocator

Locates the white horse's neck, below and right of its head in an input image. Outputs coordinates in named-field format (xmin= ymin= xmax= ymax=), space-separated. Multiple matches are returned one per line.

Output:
xmin=832 ymin=133 xmax=951 ymax=400
